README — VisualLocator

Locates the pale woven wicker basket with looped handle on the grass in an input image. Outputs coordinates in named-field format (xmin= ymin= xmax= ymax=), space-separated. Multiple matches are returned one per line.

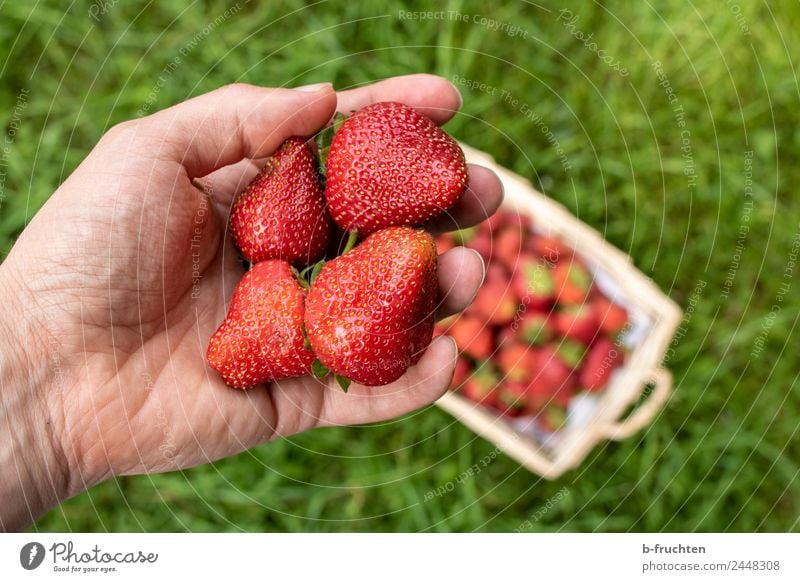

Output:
xmin=437 ymin=144 xmax=681 ymax=479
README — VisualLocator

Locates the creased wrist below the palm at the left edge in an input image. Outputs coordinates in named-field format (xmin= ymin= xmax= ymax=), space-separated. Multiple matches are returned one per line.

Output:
xmin=0 ymin=264 xmax=77 ymax=531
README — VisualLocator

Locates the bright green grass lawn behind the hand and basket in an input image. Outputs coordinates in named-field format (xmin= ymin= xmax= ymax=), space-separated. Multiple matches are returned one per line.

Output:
xmin=0 ymin=0 xmax=800 ymax=531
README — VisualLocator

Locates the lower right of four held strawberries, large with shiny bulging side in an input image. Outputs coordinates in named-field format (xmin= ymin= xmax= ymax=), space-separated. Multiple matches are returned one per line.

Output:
xmin=305 ymin=227 xmax=439 ymax=386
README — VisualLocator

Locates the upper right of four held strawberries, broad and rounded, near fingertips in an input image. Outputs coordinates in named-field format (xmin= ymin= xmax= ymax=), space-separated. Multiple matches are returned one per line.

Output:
xmin=325 ymin=102 xmax=467 ymax=234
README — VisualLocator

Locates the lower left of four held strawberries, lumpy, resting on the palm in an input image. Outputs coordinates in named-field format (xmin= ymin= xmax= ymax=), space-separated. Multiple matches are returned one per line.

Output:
xmin=206 ymin=260 xmax=314 ymax=388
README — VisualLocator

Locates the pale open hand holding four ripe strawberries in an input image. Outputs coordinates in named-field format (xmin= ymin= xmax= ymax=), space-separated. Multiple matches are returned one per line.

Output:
xmin=0 ymin=75 xmax=502 ymax=528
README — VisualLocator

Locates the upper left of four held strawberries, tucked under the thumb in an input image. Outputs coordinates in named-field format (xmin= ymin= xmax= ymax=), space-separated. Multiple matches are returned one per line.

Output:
xmin=230 ymin=137 xmax=332 ymax=264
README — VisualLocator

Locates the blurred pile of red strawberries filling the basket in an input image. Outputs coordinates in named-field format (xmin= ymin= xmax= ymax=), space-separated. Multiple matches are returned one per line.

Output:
xmin=436 ymin=209 xmax=628 ymax=431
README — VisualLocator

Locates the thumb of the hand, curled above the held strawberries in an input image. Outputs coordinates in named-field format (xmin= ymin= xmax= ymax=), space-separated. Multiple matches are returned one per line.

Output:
xmin=140 ymin=83 xmax=336 ymax=178
